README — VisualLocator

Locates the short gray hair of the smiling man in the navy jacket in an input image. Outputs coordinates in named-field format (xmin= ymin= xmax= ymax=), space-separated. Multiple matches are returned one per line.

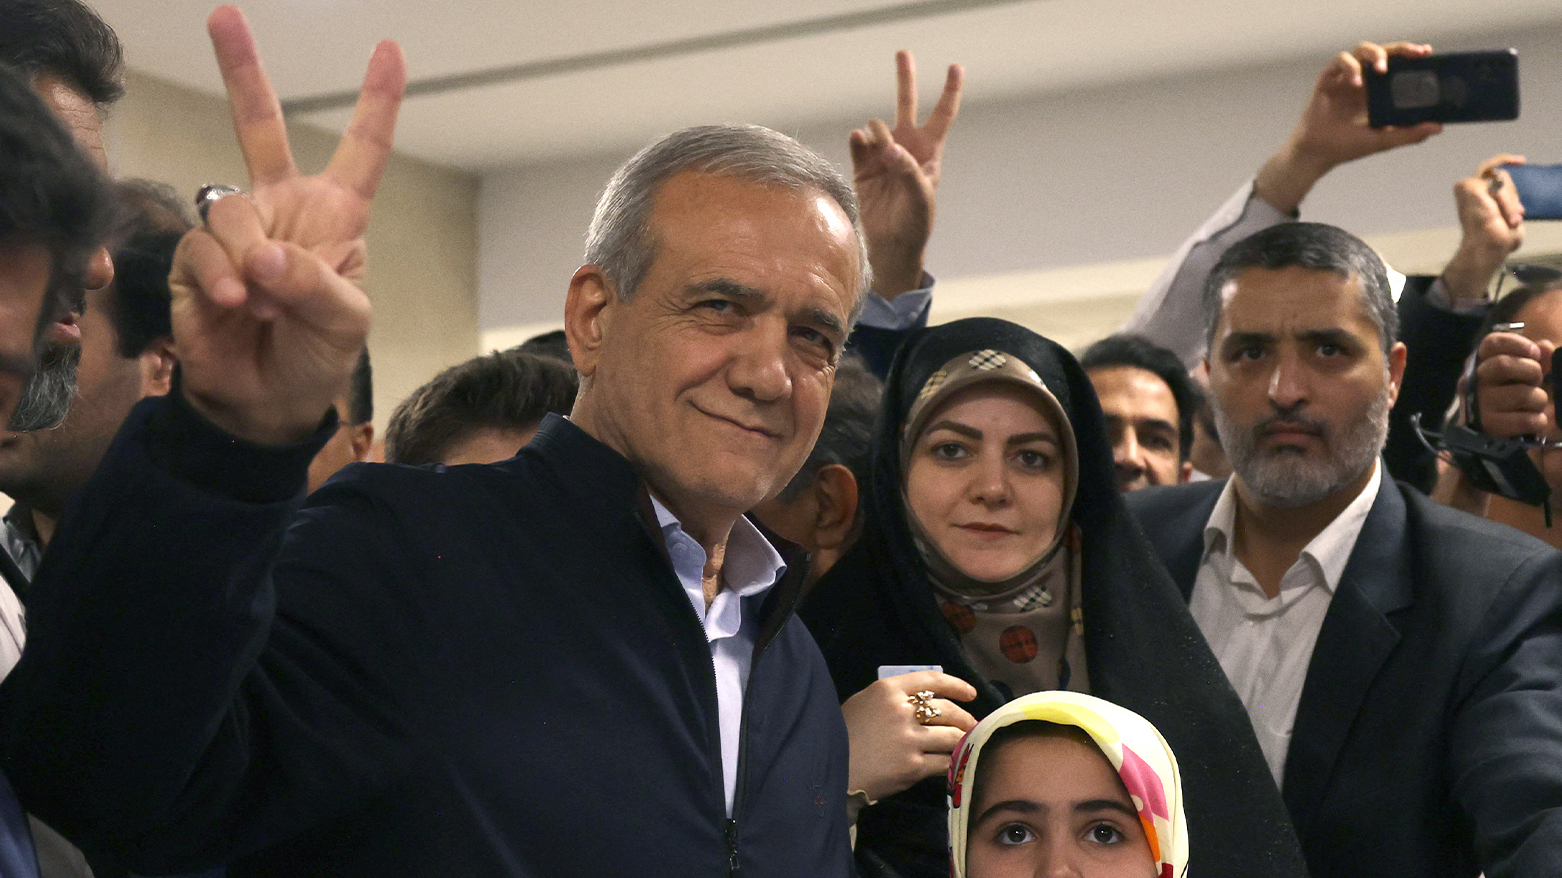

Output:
xmin=586 ymin=125 xmax=872 ymax=323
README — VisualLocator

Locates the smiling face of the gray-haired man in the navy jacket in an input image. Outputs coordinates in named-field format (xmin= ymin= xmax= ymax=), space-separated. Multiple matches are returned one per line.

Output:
xmin=570 ymin=172 xmax=862 ymax=522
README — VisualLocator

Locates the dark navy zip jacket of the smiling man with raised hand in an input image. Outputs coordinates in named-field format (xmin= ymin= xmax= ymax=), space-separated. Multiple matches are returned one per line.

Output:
xmin=0 ymin=397 xmax=850 ymax=878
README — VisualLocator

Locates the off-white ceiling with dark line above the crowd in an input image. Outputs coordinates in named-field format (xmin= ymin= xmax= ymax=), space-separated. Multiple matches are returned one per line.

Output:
xmin=89 ymin=0 xmax=1562 ymax=170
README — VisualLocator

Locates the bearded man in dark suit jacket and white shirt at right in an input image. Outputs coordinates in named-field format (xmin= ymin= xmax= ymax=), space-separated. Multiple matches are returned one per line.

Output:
xmin=1128 ymin=223 xmax=1562 ymax=878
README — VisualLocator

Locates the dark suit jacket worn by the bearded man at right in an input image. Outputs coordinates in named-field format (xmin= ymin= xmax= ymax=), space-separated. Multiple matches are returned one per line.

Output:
xmin=1128 ymin=481 xmax=1562 ymax=878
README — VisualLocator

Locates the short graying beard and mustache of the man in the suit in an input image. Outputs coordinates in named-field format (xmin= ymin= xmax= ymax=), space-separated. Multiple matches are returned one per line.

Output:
xmin=1214 ymin=386 xmax=1390 ymax=508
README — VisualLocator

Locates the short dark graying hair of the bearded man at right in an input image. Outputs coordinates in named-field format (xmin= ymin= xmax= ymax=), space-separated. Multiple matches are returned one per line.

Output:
xmin=1204 ymin=222 xmax=1400 ymax=353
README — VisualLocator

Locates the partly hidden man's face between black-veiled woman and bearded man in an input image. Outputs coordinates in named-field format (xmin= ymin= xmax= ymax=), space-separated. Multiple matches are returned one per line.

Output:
xmin=1090 ymin=359 xmax=1189 ymax=492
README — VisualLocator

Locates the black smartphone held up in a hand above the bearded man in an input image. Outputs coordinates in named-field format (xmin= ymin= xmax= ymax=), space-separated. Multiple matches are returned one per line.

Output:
xmin=1365 ymin=48 xmax=1518 ymax=128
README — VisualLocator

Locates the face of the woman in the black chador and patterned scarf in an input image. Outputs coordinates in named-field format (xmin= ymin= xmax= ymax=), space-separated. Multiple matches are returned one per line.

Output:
xmin=906 ymin=383 xmax=1065 ymax=583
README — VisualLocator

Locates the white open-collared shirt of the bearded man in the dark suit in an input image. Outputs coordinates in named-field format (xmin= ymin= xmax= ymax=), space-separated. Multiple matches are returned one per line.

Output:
xmin=1189 ymin=461 xmax=1382 ymax=784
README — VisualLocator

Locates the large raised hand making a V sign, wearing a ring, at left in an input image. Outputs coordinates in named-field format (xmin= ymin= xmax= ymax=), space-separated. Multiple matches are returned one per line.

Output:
xmin=170 ymin=6 xmax=406 ymax=445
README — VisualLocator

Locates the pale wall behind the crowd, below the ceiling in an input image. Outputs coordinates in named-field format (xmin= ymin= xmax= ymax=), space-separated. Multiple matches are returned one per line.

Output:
xmin=478 ymin=18 xmax=1562 ymax=345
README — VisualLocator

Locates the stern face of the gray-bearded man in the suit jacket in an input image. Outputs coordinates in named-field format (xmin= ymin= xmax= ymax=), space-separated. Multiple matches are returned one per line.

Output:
xmin=1209 ymin=266 xmax=1404 ymax=506
